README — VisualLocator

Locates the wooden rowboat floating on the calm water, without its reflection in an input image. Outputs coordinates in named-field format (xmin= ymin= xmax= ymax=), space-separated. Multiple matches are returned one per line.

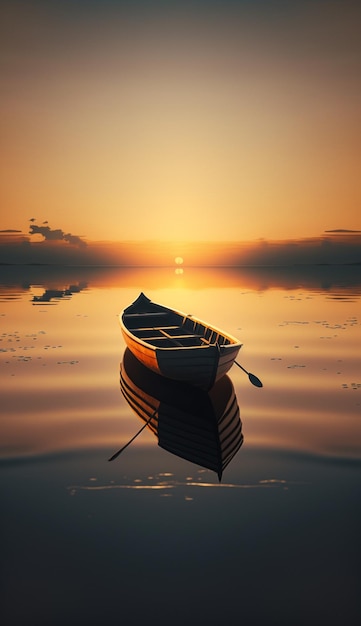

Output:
xmin=119 ymin=293 xmax=242 ymax=390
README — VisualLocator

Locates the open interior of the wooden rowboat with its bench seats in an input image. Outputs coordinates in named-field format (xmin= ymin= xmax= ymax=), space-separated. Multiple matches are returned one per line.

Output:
xmin=123 ymin=311 xmax=231 ymax=348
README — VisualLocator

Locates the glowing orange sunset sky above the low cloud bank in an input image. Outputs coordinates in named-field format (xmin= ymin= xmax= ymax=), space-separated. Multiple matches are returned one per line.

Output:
xmin=0 ymin=0 xmax=361 ymax=242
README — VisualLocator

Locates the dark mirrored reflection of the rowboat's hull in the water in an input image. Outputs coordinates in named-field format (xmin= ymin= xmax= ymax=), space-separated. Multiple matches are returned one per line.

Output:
xmin=120 ymin=348 xmax=243 ymax=480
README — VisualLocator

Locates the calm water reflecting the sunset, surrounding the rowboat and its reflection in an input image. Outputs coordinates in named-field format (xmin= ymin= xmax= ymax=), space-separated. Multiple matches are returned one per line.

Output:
xmin=0 ymin=267 xmax=361 ymax=626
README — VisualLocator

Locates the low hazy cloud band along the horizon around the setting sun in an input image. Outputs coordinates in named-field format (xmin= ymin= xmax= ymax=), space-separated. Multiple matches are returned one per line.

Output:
xmin=0 ymin=232 xmax=361 ymax=267
